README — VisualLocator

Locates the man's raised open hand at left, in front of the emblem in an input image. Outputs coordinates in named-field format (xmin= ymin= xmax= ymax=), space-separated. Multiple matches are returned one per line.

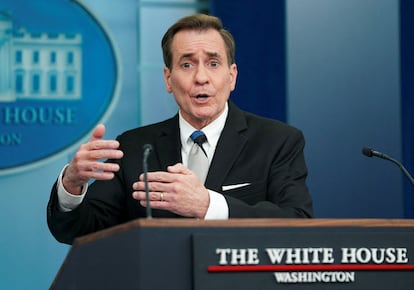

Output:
xmin=62 ymin=124 xmax=124 ymax=195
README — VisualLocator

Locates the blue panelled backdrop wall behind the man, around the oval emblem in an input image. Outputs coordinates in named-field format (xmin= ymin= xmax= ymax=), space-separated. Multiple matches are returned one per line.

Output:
xmin=0 ymin=0 xmax=414 ymax=289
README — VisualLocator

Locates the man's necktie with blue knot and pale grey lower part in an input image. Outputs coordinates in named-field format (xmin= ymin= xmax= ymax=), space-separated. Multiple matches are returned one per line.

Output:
xmin=188 ymin=131 xmax=208 ymax=183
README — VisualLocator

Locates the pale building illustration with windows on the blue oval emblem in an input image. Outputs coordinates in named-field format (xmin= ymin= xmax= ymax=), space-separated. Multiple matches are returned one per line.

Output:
xmin=0 ymin=11 xmax=82 ymax=102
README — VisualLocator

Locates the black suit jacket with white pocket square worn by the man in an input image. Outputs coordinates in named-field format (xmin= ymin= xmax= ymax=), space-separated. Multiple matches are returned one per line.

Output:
xmin=47 ymin=101 xmax=313 ymax=243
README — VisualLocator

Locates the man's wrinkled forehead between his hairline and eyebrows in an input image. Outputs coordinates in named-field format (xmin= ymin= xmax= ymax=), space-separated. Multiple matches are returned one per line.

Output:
xmin=171 ymin=29 xmax=226 ymax=58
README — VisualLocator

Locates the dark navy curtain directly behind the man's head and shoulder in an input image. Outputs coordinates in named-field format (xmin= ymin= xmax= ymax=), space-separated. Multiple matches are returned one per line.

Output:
xmin=210 ymin=0 xmax=286 ymax=121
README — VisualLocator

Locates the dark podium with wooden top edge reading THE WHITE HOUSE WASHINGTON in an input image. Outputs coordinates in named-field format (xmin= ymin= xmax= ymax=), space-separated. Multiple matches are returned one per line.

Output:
xmin=51 ymin=219 xmax=414 ymax=290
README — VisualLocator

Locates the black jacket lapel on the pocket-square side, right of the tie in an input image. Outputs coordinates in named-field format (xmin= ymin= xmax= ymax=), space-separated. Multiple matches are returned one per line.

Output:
xmin=205 ymin=101 xmax=247 ymax=192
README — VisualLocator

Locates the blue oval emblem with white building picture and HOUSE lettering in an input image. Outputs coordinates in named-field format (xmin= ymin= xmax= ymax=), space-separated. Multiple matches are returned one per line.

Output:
xmin=0 ymin=0 xmax=119 ymax=175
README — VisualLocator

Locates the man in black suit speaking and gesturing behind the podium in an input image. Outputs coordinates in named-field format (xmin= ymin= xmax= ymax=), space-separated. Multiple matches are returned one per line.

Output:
xmin=47 ymin=14 xmax=313 ymax=243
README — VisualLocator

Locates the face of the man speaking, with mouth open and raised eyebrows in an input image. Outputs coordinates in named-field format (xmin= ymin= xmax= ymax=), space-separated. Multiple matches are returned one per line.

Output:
xmin=164 ymin=29 xmax=237 ymax=129
